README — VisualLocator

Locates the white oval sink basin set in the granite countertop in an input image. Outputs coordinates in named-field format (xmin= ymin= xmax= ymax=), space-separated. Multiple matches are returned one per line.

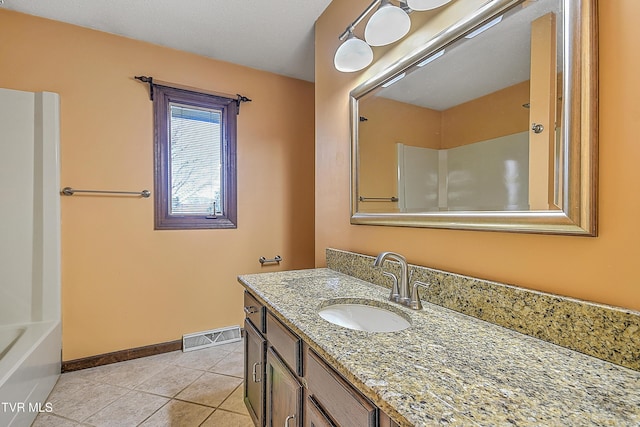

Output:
xmin=318 ymin=303 xmax=411 ymax=332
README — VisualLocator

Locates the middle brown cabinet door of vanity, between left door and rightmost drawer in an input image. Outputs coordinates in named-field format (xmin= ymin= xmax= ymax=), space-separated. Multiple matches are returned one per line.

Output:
xmin=266 ymin=347 xmax=302 ymax=427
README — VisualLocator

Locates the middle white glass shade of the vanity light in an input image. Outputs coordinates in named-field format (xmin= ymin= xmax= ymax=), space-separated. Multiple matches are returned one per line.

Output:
xmin=364 ymin=0 xmax=411 ymax=46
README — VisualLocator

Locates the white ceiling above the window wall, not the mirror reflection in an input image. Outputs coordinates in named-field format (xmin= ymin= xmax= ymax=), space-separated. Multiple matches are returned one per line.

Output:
xmin=0 ymin=0 xmax=330 ymax=81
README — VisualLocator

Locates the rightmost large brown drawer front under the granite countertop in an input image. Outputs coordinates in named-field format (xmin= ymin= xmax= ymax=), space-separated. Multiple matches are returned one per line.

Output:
xmin=305 ymin=350 xmax=377 ymax=427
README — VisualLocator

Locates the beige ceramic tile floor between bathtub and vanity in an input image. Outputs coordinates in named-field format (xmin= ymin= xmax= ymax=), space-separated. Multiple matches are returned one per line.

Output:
xmin=32 ymin=341 xmax=253 ymax=427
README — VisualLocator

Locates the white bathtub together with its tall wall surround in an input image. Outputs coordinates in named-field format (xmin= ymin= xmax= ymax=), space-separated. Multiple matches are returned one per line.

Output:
xmin=0 ymin=89 xmax=62 ymax=427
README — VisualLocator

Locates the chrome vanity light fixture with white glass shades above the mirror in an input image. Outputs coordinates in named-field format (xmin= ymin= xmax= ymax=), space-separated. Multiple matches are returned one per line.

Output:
xmin=333 ymin=0 xmax=451 ymax=73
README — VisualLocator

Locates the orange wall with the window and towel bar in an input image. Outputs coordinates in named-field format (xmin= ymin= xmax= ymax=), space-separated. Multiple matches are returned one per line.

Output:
xmin=0 ymin=11 xmax=314 ymax=360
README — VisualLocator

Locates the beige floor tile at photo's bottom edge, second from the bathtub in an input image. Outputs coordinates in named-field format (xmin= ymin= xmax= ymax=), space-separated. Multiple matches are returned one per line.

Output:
xmin=85 ymin=391 xmax=169 ymax=427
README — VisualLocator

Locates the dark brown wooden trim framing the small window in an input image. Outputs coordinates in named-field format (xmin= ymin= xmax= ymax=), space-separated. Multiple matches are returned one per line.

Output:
xmin=153 ymin=85 xmax=238 ymax=230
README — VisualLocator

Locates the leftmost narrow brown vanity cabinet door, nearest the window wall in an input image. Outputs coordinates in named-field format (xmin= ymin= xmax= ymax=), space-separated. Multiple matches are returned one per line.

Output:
xmin=244 ymin=319 xmax=267 ymax=427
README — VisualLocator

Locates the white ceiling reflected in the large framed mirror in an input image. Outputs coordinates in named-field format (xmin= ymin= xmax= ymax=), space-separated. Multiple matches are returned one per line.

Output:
xmin=378 ymin=0 xmax=563 ymax=111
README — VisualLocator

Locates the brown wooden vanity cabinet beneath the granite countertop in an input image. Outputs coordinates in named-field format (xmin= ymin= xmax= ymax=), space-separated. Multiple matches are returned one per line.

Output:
xmin=244 ymin=291 xmax=396 ymax=427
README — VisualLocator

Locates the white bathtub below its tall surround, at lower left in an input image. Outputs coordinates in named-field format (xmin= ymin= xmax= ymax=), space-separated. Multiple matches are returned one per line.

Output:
xmin=0 ymin=322 xmax=61 ymax=427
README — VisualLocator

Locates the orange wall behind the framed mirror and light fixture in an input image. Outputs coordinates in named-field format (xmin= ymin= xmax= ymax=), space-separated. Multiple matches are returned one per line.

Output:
xmin=315 ymin=0 xmax=640 ymax=310
